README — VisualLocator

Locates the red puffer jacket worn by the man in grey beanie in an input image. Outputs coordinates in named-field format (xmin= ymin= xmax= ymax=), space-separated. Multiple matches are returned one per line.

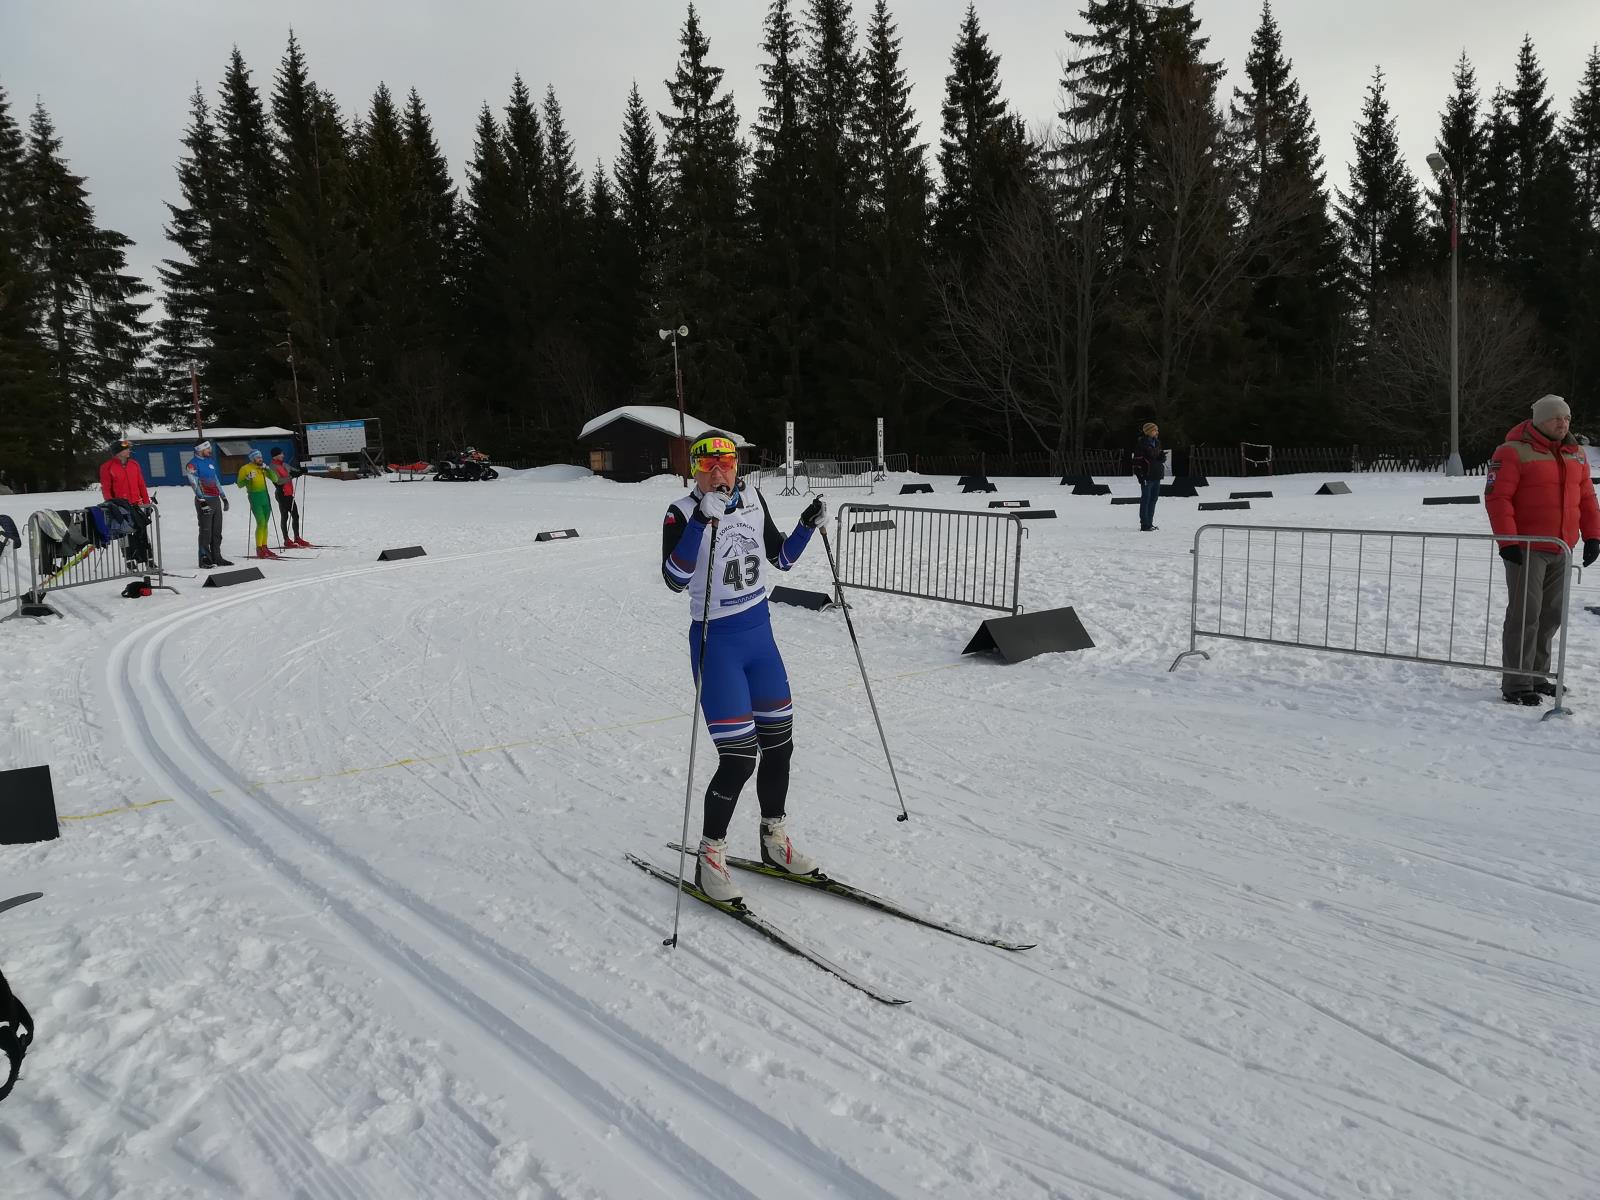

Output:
xmin=1483 ymin=421 xmax=1600 ymax=549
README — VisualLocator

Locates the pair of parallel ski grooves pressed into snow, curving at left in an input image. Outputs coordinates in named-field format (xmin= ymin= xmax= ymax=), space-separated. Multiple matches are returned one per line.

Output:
xmin=109 ymin=552 xmax=915 ymax=1200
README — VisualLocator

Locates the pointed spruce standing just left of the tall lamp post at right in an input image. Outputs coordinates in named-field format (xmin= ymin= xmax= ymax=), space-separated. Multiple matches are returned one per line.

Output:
xmin=1338 ymin=69 xmax=1424 ymax=330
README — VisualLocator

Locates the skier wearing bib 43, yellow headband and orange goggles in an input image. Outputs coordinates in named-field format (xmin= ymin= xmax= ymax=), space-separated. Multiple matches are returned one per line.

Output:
xmin=661 ymin=430 xmax=827 ymax=901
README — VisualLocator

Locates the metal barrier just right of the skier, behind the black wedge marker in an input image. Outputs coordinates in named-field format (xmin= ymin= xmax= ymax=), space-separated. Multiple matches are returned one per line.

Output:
xmin=837 ymin=501 xmax=1024 ymax=616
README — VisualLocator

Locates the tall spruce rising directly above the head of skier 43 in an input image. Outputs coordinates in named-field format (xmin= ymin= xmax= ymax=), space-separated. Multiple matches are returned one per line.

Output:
xmin=658 ymin=5 xmax=745 ymax=437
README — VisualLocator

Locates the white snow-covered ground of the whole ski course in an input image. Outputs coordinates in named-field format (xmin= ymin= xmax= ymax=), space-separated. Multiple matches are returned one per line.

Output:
xmin=0 ymin=470 xmax=1600 ymax=1200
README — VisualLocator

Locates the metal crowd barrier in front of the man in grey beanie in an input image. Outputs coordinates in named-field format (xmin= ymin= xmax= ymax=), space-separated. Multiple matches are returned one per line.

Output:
xmin=1170 ymin=525 xmax=1573 ymax=717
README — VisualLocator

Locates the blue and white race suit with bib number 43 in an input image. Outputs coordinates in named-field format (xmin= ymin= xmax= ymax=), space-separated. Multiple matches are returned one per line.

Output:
xmin=661 ymin=486 xmax=811 ymax=838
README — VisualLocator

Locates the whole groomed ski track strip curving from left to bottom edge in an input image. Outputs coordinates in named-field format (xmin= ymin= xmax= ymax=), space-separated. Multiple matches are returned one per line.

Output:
xmin=107 ymin=542 xmax=890 ymax=1200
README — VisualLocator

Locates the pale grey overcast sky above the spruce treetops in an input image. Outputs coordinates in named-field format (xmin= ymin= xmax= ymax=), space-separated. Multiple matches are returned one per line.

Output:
xmin=0 ymin=0 xmax=1600 ymax=305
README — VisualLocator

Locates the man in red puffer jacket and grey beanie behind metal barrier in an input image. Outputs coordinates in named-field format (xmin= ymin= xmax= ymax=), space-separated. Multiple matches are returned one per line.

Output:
xmin=1483 ymin=395 xmax=1600 ymax=706
